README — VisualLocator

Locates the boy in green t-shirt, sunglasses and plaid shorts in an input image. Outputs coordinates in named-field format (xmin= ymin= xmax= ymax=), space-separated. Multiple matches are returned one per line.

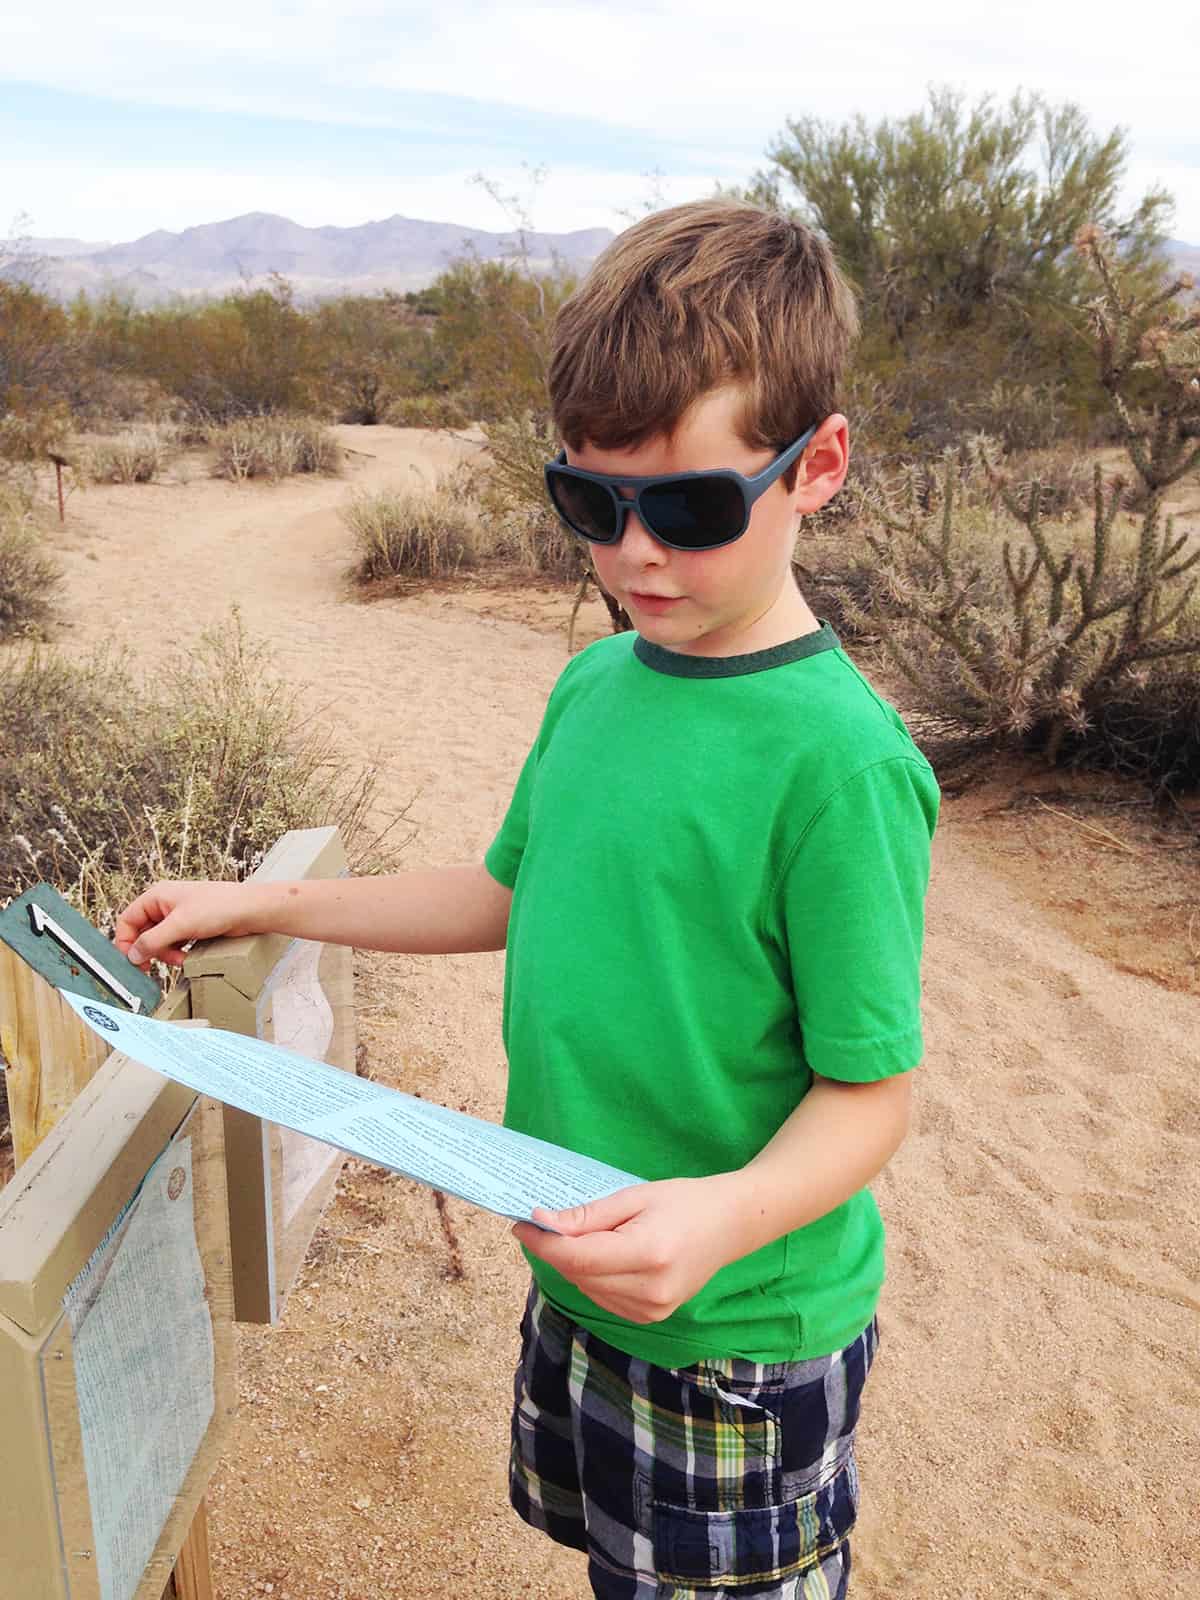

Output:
xmin=115 ymin=200 xmax=938 ymax=1600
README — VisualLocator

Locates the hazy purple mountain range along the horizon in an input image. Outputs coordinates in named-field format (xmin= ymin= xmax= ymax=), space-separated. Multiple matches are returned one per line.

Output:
xmin=11 ymin=211 xmax=1200 ymax=304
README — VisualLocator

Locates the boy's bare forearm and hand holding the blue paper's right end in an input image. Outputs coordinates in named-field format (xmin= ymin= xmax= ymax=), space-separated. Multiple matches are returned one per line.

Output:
xmin=512 ymin=1072 xmax=912 ymax=1322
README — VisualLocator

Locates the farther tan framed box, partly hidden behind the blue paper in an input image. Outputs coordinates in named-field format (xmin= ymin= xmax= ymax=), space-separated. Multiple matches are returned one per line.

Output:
xmin=184 ymin=827 xmax=355 ymax=1323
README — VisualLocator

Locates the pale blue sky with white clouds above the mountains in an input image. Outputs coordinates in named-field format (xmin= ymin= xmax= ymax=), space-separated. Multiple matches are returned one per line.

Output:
xmin=0 ymin=0 xmax=1200 ymax=243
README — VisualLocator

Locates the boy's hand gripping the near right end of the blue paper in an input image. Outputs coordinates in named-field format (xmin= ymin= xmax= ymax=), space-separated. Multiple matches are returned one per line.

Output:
xmin=512 ymin=1173 xmax=746 ymax=1322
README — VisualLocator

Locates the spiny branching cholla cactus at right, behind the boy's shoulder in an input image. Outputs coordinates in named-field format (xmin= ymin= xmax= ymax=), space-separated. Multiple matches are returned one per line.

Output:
xmin=842 ymin=226 xmax=1200 ymax=762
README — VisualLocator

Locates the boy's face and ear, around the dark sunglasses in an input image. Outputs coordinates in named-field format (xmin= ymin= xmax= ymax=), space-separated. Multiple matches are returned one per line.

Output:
xmin=566 ymin=386 xmax=846 ymax=656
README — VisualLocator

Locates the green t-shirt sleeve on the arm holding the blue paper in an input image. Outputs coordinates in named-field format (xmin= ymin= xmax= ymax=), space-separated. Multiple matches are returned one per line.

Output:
xmin=779 ymin=755 xmax=939 ymax=1083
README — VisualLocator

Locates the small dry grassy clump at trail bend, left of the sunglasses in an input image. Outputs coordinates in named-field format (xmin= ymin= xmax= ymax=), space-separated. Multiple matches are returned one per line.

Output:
xmin=342 ymin=478 xmax=480 ymax=584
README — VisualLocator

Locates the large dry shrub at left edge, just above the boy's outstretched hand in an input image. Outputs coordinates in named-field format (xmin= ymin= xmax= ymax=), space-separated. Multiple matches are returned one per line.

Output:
xmin=0 ymin=613 xmax=405 ymax=936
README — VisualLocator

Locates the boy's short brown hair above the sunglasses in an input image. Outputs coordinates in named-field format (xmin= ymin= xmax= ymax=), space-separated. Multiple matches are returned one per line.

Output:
xmin=549 ymin=198 xmax=858 ymax=488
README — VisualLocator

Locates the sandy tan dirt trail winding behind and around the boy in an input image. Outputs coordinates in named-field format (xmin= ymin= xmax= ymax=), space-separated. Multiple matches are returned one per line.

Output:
xmin=37 ymin=427 xmax=1200 ymax=1600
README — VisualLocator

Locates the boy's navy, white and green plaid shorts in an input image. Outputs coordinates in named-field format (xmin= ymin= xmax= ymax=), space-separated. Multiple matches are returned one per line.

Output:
xmin=509 ymin=1283 xmax=878 ymax=1600
